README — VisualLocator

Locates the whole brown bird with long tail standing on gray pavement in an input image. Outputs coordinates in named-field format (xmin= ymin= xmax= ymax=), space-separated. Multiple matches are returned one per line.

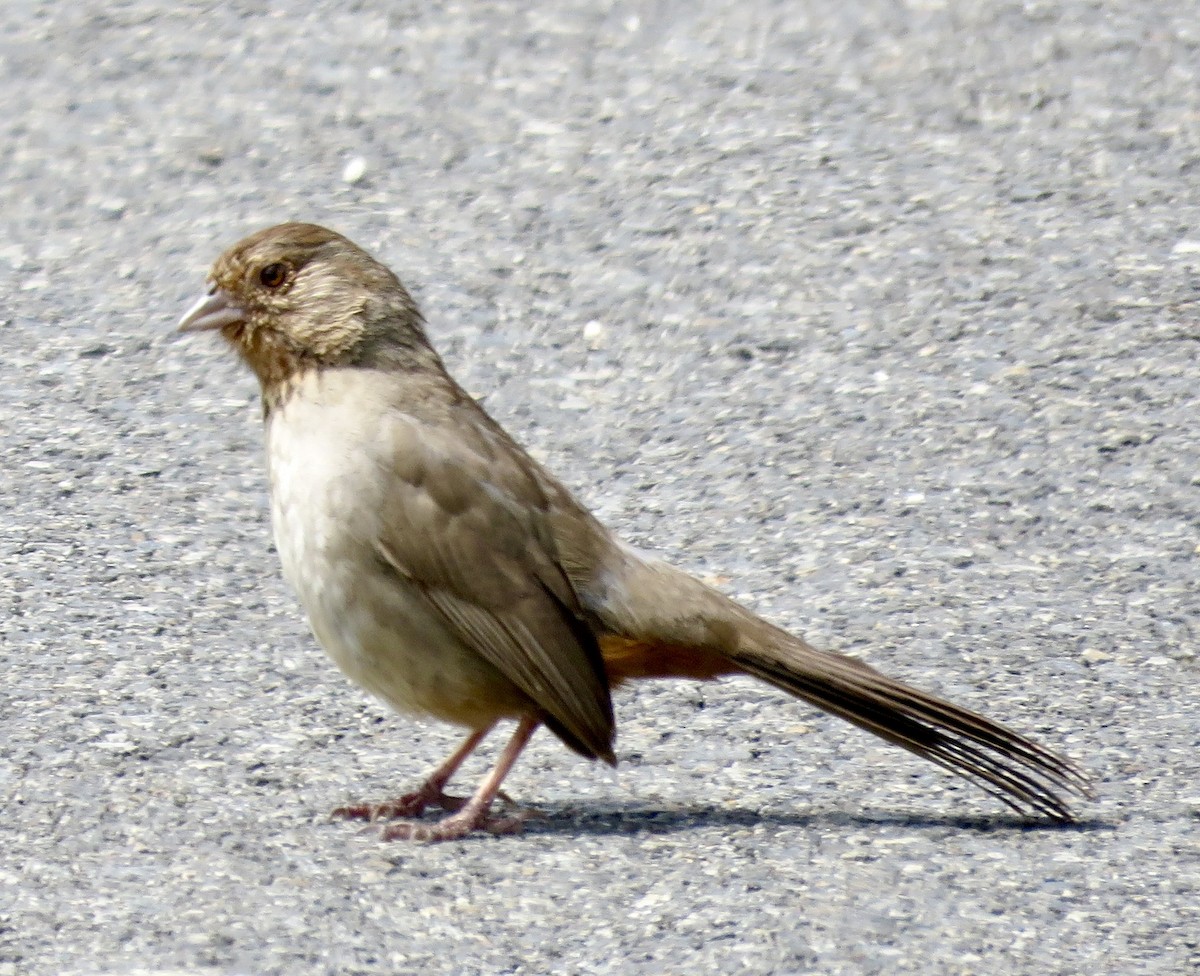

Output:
xmin=179 ymin=222 xmax=1093 ymax=842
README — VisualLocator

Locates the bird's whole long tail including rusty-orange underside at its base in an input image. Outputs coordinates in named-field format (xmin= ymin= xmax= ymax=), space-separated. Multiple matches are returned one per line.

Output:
xmin=601 ymin=559 xmax=1092 ymax=822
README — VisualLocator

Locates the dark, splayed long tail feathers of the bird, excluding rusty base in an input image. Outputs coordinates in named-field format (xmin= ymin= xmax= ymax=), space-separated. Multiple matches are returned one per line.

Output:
xmin=731 ymin=637 xmax=1092 ymax=822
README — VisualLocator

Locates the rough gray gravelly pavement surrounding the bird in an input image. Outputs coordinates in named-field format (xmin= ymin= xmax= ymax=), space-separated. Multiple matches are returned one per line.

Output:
xmin=0 ymin=0 xmax=1200 ymax=976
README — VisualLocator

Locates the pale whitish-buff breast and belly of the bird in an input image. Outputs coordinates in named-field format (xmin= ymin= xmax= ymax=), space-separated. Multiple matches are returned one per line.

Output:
xmin=266 ymin=373 xmax=528 ymax=727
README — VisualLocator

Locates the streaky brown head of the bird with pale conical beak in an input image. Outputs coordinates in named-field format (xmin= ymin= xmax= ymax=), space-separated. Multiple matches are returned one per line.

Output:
xmin=179 ymin=223 xmax=432 ymax=395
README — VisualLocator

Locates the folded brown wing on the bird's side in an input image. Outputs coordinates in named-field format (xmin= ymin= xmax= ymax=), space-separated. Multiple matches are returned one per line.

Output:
xmin=377 ymin=413 xmax=613 ymax=761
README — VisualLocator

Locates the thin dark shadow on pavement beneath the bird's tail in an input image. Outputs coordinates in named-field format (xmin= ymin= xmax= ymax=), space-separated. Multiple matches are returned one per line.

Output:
xmin=511 ymin=807 xmax=1117 ymax=837
